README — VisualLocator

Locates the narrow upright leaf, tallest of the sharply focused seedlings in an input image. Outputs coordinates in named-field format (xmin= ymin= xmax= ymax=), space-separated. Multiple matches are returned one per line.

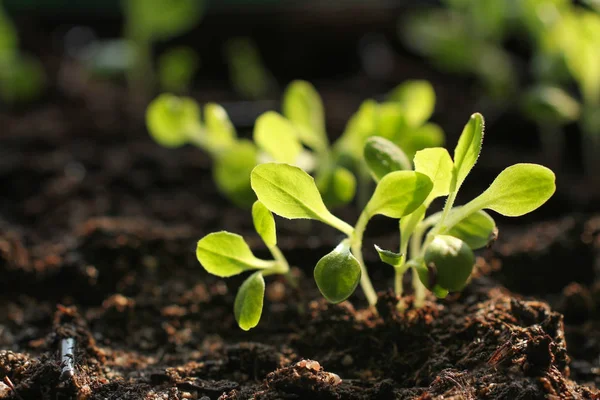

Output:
xmin=450 ymin=113 xmax=484 ymax=192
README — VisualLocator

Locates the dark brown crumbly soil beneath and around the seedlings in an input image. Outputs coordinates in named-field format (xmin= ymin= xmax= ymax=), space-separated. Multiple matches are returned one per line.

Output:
xmin=0 ymin=61 xmax=600 ymax=400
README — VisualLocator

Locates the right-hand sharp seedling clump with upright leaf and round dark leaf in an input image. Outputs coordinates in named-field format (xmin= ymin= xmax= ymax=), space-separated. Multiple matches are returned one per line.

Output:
xmin=365 ymin=114 xmax=556 ymax=307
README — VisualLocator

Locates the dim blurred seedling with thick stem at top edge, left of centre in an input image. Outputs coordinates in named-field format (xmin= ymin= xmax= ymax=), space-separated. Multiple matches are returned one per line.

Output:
xmin=124 ymin=0 xmax=204 ymax=93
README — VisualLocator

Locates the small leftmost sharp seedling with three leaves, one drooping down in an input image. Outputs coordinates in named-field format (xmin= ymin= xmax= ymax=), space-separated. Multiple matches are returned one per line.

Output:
xmin=196 ymin=201 xmax=290 ymax=331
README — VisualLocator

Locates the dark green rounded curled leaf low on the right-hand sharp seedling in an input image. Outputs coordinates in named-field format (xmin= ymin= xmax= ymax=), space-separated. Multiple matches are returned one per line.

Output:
xmin=418 ymin=235 xmax=475 ymax=292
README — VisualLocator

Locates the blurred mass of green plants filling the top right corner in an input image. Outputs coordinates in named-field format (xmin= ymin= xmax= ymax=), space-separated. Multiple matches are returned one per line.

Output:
xmin=401 ymin=0 xmax=600 ymax=173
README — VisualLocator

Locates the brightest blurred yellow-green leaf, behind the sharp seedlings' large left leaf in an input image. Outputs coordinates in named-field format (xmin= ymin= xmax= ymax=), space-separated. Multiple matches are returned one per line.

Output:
xmin=254 ymin=111 xmax=302 ymax=164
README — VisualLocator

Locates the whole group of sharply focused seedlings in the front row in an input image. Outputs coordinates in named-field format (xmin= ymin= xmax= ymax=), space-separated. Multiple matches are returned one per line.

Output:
xmin=197 ymin=114 xmax=555 ymax=329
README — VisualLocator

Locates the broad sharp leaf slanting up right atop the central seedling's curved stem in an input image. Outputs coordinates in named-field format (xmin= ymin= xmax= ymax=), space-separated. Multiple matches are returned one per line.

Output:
xmin=365 ymin=171 xmax=433 ymax=218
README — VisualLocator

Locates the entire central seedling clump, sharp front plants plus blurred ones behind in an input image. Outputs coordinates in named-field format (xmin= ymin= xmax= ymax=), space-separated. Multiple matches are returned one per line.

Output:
xmin=147 ymin=81 xmax=555 ymax=330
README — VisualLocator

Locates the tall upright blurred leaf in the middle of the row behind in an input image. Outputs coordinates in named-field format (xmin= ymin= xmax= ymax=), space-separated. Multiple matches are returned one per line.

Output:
xmin=282 ymin=81 xmax=328 ymax=151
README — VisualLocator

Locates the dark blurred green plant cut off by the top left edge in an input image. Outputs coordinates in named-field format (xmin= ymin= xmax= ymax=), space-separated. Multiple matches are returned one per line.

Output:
xmin=0 ymin=2 xmax=46 ymax=104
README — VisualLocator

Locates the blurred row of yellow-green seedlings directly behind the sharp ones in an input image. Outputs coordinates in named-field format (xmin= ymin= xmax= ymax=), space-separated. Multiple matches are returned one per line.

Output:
xmin=147 ymin=81 xmax=444 ymax=207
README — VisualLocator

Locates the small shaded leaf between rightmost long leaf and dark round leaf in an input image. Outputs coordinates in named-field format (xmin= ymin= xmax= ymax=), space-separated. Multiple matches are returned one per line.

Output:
xmin=447 ymin=210 xmax=498 ymax=250
